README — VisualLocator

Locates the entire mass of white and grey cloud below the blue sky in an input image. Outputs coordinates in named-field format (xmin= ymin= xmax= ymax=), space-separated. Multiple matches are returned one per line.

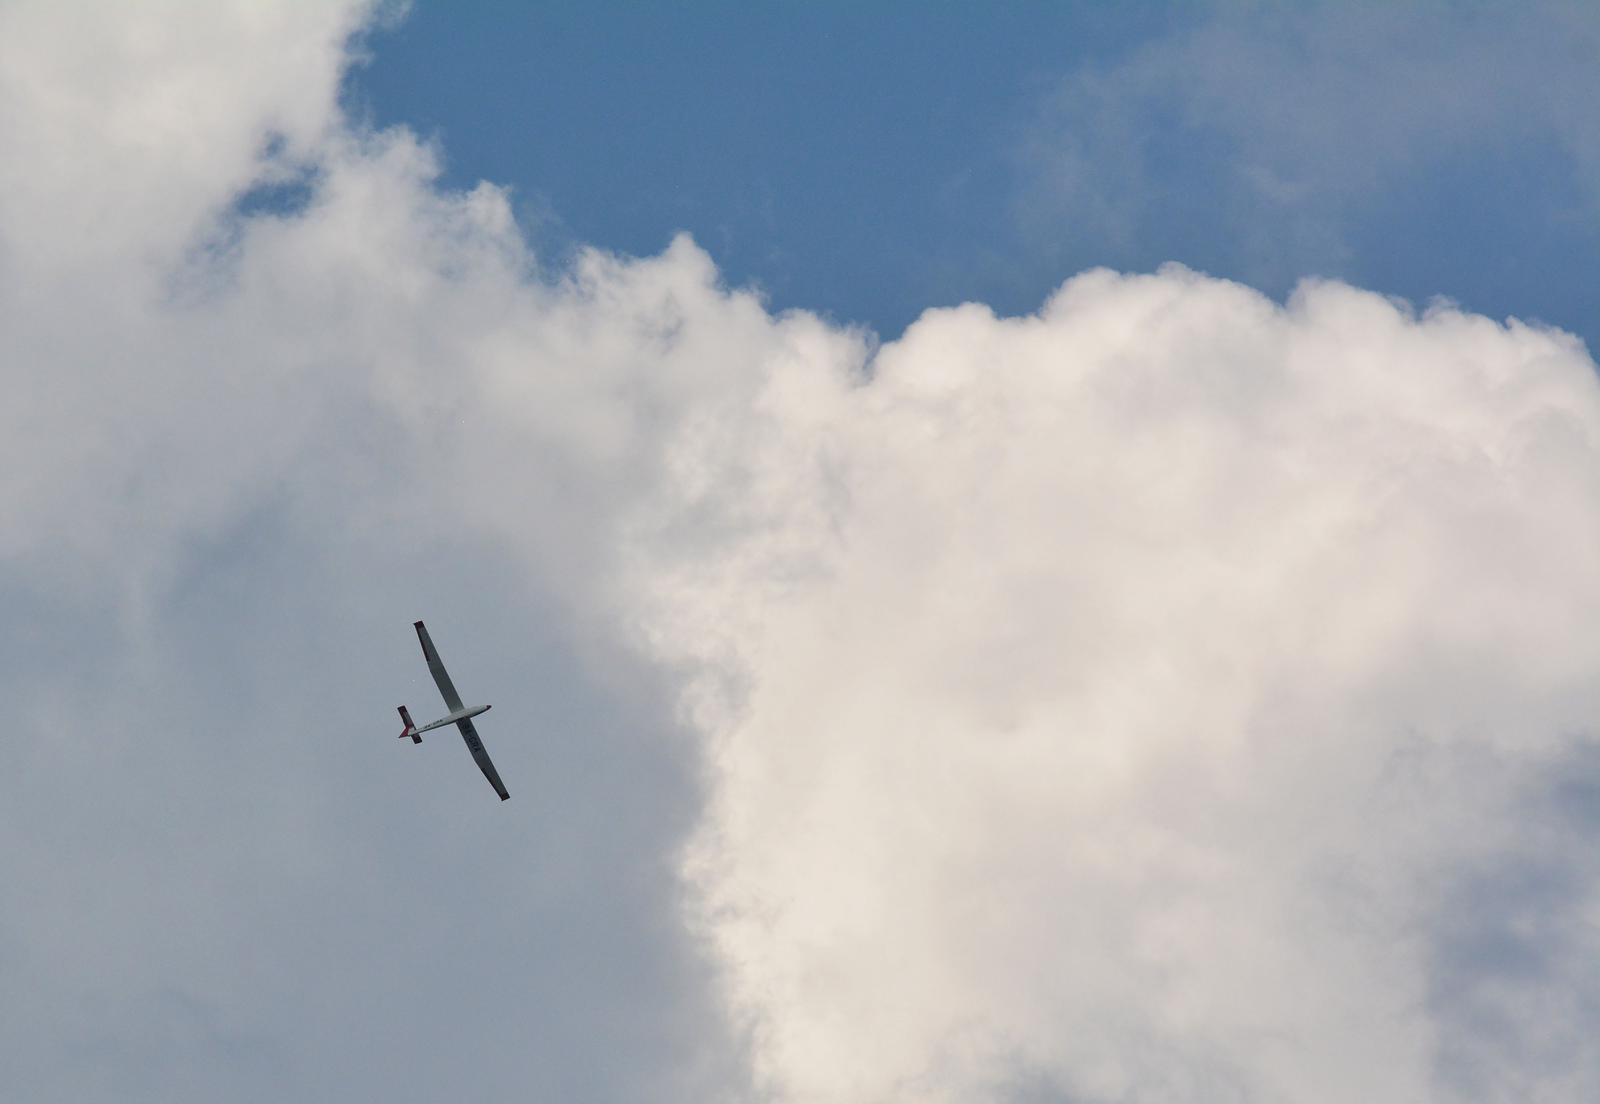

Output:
xmin=9 ymin=3 xmax=1600 ymax=1102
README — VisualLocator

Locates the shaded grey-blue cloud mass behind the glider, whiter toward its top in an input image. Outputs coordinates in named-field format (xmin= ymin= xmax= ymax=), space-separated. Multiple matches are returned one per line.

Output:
xmin=0 ymin=3 xmax=755 ymax=1101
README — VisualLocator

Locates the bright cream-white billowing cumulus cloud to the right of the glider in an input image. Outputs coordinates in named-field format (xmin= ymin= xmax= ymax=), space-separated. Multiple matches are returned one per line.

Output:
xmin=640 ymin=267 xmax=1600 ymax=1102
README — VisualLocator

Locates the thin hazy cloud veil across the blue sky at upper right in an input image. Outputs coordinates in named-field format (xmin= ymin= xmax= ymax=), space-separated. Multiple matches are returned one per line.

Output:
xmin=1016 ymin=0 xmax=1600 ymax=326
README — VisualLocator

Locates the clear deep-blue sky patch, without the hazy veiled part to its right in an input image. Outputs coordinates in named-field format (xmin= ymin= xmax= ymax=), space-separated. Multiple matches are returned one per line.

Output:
xmin=352 ymin=3 xmax=1168 ymax=333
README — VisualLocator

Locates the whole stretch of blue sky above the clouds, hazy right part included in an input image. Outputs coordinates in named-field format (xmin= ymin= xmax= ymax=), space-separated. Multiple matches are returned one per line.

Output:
xmin=349 ymin=2 xmax=1600 ymax=346
